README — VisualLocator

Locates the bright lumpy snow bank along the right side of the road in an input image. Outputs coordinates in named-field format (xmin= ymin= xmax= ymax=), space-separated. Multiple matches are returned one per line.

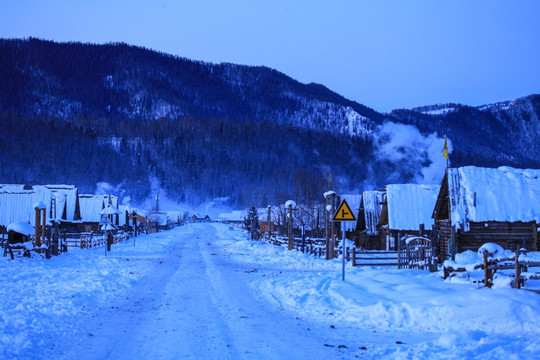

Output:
xmin=213 ymin=225 xmax=540 ymax=335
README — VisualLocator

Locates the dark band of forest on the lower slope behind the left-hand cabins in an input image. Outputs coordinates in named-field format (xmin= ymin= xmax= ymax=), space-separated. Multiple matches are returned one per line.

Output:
xmin=0 ymin=113 xmax=378 ymax=206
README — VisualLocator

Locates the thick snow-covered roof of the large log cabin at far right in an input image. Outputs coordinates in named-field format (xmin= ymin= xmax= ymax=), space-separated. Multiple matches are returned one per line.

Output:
xmin=448 ymin=166 xmax=540 ymax=230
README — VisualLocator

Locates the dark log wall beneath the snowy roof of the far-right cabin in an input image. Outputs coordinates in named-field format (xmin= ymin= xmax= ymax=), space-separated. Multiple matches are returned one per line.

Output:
xmin=456 ymin=222 xmax=538 ymax=252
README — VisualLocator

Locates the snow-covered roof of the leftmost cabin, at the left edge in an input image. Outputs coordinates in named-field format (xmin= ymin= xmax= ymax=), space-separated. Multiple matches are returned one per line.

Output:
xmin=0 ymin=184 xmax=52 ymax=226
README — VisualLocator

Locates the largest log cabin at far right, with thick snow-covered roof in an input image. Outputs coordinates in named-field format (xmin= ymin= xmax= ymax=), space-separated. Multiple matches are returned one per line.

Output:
xmin=433 ymin=166 xmax=540 ymax=261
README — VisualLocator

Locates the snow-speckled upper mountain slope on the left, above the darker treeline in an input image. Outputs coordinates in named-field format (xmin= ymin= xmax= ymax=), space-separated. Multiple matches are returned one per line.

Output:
xmin=0 ymin=39 xmax=382 ymax=135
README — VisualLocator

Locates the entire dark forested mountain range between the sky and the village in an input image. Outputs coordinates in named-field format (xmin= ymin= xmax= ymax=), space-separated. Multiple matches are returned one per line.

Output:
xmin=0 ymin=39 xmax=540 ymax=206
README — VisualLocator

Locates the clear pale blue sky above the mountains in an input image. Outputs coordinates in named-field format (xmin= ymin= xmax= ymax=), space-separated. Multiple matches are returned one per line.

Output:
xmin=0 ymin=0 xmax=540 ymax=111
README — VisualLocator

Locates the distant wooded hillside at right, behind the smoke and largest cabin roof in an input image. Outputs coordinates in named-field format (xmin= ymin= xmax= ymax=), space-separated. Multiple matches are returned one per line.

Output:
xmin=388 ymin=95 xmax=540 ymax=168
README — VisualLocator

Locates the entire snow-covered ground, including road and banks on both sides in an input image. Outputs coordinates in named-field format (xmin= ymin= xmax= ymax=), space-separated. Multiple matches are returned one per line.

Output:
xmin=0 ymin=224 xmax=540 ymax=359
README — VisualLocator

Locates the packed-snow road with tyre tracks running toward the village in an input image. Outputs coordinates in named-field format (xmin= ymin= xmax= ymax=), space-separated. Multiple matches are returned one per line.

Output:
xmin=52 ymin=225 xmax=384 ymax=359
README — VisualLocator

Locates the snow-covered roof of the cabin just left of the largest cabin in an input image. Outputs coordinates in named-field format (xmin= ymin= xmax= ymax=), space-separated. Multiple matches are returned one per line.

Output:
xmin=386 ymin=184 xmax=440 ymax=230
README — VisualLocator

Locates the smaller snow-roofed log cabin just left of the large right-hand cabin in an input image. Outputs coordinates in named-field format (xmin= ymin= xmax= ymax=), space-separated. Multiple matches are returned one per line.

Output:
xmin=377 ymin=184 xmax=440 ymax=250
